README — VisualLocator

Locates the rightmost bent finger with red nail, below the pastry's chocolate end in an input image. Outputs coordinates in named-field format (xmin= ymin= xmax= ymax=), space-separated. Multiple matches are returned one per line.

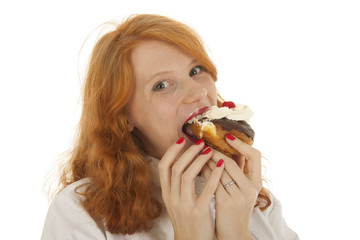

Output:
xmin=226 ymin=134 xmax=261 ymax=181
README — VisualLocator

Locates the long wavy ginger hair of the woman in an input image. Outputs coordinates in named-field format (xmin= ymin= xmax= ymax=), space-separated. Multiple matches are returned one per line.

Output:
xmin=60 ymin=14 xmax=270 ymax=234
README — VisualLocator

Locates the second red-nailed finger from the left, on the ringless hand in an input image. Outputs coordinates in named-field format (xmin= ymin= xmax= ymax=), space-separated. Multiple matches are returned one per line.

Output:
xmin=170 ymin=140 xmax=204 ymax=197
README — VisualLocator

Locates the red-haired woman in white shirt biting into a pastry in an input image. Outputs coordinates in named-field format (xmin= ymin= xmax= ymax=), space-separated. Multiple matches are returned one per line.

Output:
xmin=42 ymin=15 xmax=298 ymax=239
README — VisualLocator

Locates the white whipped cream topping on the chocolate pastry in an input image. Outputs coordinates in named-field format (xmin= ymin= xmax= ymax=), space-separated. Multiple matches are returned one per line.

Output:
xmin=189 ymin=104 xmax=254 ymax=123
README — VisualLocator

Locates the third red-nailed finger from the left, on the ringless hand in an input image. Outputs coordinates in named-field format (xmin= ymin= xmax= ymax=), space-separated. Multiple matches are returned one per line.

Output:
xmin=181 ymin=148 xmax=212 ymax=201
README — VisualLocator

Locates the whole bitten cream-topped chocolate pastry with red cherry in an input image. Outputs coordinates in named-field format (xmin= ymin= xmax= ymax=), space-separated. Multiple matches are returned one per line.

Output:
xmin=183 ymin=102 xmax=255 ymax=157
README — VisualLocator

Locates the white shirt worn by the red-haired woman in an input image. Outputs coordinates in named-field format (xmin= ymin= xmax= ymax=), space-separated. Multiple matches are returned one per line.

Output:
xmin=41 ymin=158 xmax=299 ymax=240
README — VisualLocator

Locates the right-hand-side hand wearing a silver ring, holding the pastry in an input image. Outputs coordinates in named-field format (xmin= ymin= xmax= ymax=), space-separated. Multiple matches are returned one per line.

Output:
xmin=203 ymin=135 xmax=262 ymax=240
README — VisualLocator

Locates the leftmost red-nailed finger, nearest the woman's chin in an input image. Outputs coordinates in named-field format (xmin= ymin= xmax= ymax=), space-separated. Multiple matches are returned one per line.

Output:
xmin=158 ymin=137 xmax=185 ymax=193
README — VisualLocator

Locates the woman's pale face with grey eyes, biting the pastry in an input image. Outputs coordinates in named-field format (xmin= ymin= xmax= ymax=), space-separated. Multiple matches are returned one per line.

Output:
xmin=128 ymin=40 xmax=217 ymax=158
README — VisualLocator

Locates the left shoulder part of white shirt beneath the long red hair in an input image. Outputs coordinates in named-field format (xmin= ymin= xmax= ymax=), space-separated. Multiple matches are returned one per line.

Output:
xmin=41 ymin=179 xmax=173 ymax=240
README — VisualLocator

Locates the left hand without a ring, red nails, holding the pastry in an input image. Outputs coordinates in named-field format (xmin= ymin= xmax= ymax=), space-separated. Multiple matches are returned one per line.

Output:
xmin=158 ymin=138 xmax=224 ymax=240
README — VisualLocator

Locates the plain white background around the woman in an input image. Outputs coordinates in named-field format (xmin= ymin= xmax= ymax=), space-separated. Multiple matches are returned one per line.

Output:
xmin=0 ymin=0 xmax=360 ymax=239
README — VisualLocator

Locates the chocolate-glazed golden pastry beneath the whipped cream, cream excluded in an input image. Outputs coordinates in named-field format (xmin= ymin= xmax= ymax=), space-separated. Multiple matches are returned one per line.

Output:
xmin=183 ymin=118 xmax=255 ymax=157
